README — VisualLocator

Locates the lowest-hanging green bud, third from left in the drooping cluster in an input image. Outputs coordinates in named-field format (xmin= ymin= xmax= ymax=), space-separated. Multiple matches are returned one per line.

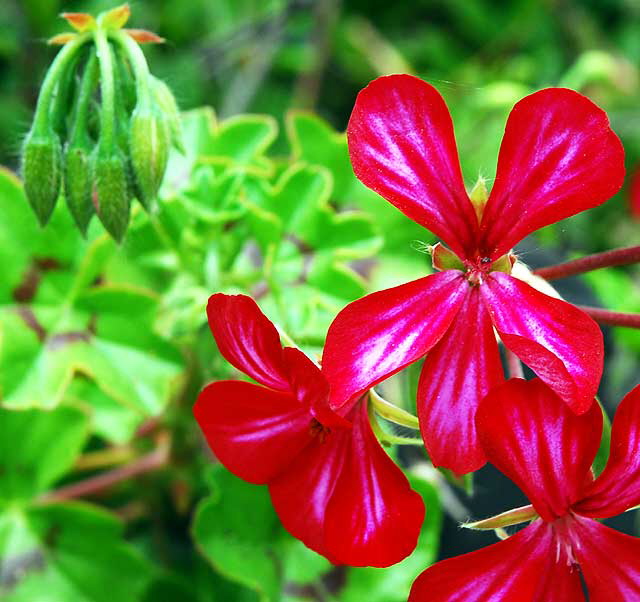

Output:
xmin=93 ymin=147 xmax=130 ymax=242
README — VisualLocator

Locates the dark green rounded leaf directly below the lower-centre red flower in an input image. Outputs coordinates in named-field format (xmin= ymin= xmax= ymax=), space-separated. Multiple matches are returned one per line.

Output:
xmin=192 ymin=467 xmax=281 ymax=602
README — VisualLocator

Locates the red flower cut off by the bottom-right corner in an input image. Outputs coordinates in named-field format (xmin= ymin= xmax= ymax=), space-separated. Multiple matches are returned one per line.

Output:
xmin=409 ymin=379 xmax=640 ymax=602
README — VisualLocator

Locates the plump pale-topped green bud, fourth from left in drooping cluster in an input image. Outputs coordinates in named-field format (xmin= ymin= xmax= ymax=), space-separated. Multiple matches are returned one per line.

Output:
xmin=129 ymin=108 xmax=170 ymax=209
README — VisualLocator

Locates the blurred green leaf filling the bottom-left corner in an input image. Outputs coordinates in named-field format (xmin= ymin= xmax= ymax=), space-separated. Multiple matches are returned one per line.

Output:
xmin=0 ymin=503 xmax=150 ymax=602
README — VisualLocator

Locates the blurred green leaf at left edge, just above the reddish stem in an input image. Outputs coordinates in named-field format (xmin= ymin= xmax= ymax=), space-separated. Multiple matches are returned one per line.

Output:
xmin=0 ymin=406 xmax=88 ymax=502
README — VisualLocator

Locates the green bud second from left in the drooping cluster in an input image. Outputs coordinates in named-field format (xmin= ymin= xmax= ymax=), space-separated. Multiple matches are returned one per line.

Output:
xmin=64 ymin=144 xmax=94 ymax=235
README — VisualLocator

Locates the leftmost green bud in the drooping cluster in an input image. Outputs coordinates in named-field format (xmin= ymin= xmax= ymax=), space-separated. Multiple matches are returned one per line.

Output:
xmin=22 ymin=130 xmax=62 ymax=226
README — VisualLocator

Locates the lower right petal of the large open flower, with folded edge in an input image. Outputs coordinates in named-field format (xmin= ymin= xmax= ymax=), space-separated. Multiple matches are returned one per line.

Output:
xmin=480 ymin=272 xmax=604 ymax=413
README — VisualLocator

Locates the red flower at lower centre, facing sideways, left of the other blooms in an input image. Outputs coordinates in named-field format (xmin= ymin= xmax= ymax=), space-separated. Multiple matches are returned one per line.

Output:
xmin=194 ymin=294 xmax=424 ymax=567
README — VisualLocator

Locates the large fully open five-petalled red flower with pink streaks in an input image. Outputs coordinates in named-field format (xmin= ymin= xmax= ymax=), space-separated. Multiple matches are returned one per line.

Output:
xmin=323 ymin=75 xmax=624 ymax=474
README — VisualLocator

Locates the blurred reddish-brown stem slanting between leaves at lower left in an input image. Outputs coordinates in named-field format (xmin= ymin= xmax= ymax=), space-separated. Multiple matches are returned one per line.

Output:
xmin=40 ymin=437 xmax=169 ymax=502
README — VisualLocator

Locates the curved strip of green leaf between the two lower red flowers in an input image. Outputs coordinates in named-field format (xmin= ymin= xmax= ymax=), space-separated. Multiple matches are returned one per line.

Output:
xmin=340 ymin=475 xmax=442 ymax=602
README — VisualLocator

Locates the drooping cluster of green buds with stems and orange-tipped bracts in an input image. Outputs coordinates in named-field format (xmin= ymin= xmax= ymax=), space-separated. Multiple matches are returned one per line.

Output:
xmin=22 ymin=4 xmax=181 ymax=241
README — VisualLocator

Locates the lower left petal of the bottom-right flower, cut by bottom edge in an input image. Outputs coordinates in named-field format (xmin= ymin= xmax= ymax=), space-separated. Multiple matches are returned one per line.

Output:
xmin=408 ymin=521 xmax=584 ymax=602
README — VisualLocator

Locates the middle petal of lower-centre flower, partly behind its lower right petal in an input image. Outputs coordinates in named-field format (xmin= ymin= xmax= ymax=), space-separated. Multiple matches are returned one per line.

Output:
xmin=269 ymin=429 xmax=351 ymax=564
